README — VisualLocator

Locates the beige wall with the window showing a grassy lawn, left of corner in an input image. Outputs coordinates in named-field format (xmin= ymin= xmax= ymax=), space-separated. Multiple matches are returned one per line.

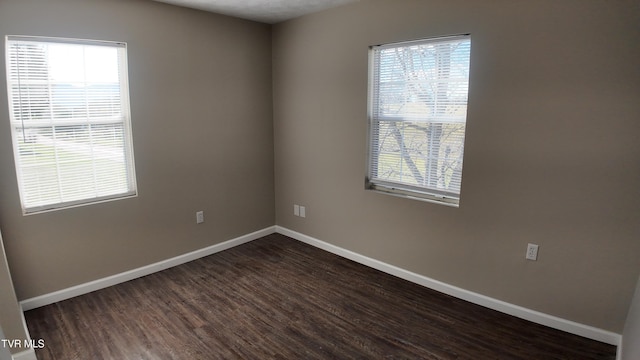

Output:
xmin=0 ymin=0 xmax=275 ymax=298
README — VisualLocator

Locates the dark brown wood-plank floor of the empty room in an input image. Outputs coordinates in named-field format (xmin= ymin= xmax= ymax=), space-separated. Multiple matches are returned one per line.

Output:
xmin=25 ymin=234 xmax=616 ymax=360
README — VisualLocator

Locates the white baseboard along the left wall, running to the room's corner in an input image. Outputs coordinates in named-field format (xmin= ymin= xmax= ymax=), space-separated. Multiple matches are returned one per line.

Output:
xmin=20 ymin=226 xmax=275 ymax=311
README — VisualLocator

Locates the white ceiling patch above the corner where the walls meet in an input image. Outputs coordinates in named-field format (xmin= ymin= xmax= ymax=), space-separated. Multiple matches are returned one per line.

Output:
xmin=155 ymin=0 xmax=359 ymax=24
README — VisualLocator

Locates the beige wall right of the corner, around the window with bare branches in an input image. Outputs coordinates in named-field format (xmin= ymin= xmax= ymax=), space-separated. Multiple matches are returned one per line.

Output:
xmin=273 ymin=0 xmax=640 ymax=333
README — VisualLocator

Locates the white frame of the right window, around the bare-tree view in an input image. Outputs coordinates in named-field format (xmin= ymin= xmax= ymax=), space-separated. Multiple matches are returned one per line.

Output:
xmin=365 ymin=34 xmax=471 ymax=207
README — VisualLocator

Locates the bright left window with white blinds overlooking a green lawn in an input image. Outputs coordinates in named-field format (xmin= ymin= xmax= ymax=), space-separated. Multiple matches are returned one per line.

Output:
xmin=6 ymin=36 xmax=136 ymax=214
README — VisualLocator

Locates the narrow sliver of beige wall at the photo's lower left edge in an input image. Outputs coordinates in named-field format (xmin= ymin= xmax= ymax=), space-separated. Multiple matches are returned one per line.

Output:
xmin=0 ymin=234 xmax=29 ymax=358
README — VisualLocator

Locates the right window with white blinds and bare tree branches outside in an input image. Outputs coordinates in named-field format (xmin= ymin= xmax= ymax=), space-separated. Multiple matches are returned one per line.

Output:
xmin=367 ymin=35 xmax=471 ymax=206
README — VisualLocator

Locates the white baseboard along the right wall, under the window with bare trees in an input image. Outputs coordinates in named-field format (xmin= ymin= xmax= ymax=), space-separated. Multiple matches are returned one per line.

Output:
xmin=276 ymin=226 xmax=622 ymax=346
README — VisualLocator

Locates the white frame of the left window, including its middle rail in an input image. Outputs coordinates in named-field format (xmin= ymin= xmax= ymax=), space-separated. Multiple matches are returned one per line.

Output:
xmin=5 ymin=35 xmax=138 ymax=215
